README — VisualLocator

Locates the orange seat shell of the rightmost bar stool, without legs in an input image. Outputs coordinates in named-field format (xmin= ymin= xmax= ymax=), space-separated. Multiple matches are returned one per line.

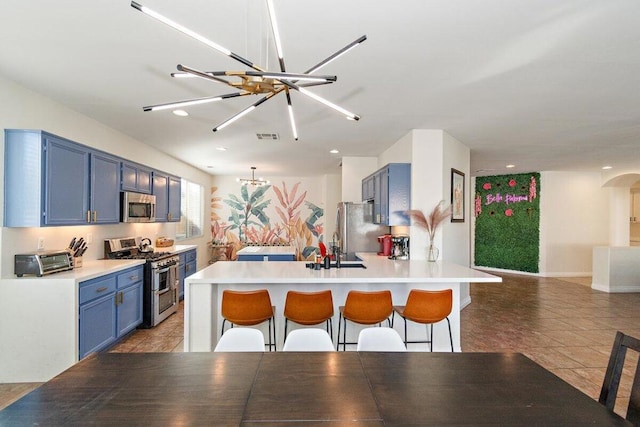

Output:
xmin=403 ymin=289 xmax=453 ymax=323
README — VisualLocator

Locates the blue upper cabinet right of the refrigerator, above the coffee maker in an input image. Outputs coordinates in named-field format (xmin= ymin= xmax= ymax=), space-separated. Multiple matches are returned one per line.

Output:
xmin=362 ymin=163 xmax=411 ymax=225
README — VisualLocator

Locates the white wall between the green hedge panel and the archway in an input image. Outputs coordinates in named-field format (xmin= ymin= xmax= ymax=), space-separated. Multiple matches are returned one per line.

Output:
xmin=540 ymin=172 xmax=608 ymax=277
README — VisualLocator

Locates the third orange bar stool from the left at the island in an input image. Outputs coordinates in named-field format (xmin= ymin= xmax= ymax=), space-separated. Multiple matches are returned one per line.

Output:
xmin=336 ymin=291 xmax=393 ymax=351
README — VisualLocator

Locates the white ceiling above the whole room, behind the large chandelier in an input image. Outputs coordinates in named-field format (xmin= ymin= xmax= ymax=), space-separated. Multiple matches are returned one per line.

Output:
xmin=0 ymin=0 xmax=640 ymax=177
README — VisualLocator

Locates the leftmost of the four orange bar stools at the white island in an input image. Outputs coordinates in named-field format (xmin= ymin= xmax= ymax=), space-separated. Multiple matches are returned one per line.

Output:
xmin=220 ymin=289 xmax=276 ymax=351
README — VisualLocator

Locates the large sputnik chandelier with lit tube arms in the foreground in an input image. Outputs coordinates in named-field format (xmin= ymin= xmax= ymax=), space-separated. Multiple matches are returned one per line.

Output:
xmin=131 ymin=0 xmax=367 ymax=141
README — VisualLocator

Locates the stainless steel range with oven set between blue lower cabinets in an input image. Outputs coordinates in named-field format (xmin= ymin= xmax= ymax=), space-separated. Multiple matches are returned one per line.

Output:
xmin=104 ymin=237 xmax=180 ymax=328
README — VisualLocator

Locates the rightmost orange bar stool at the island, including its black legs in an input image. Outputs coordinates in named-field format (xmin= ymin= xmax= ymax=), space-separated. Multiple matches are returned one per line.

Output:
xmin=393 ymin=289 xmax=453 ymax=351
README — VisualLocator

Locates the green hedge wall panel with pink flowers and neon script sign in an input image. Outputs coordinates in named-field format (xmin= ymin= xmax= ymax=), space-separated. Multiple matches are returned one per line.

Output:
xmin=474 ymin=173 xmax=540 ymax=273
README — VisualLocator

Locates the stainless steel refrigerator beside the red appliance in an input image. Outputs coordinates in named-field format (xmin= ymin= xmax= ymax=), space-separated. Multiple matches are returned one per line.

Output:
xmin=336 ymin=202 xmax=390 ymax=254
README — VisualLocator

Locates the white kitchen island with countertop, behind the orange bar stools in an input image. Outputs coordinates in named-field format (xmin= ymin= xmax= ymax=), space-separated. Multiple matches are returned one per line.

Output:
xmin=184 ymin=253 xmax=502 ymax=351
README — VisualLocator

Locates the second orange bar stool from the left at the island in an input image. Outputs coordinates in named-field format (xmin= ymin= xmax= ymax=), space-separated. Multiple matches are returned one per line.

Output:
xmin=284 ymin=290 xmax=333 ymax=341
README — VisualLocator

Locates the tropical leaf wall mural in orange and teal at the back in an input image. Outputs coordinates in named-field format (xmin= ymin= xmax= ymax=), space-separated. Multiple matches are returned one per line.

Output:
xmin=211 ymin=177 xmax=324 ymax=261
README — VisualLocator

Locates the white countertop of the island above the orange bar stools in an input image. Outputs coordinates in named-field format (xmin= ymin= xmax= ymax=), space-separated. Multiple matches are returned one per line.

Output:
xmin=186 ymin=253 xmax=502 ymax=284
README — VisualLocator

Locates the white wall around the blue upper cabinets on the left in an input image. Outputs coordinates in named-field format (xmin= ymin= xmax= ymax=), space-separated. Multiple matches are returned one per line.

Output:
xmin=0 ymin=77 xmax=211 ymax=277
